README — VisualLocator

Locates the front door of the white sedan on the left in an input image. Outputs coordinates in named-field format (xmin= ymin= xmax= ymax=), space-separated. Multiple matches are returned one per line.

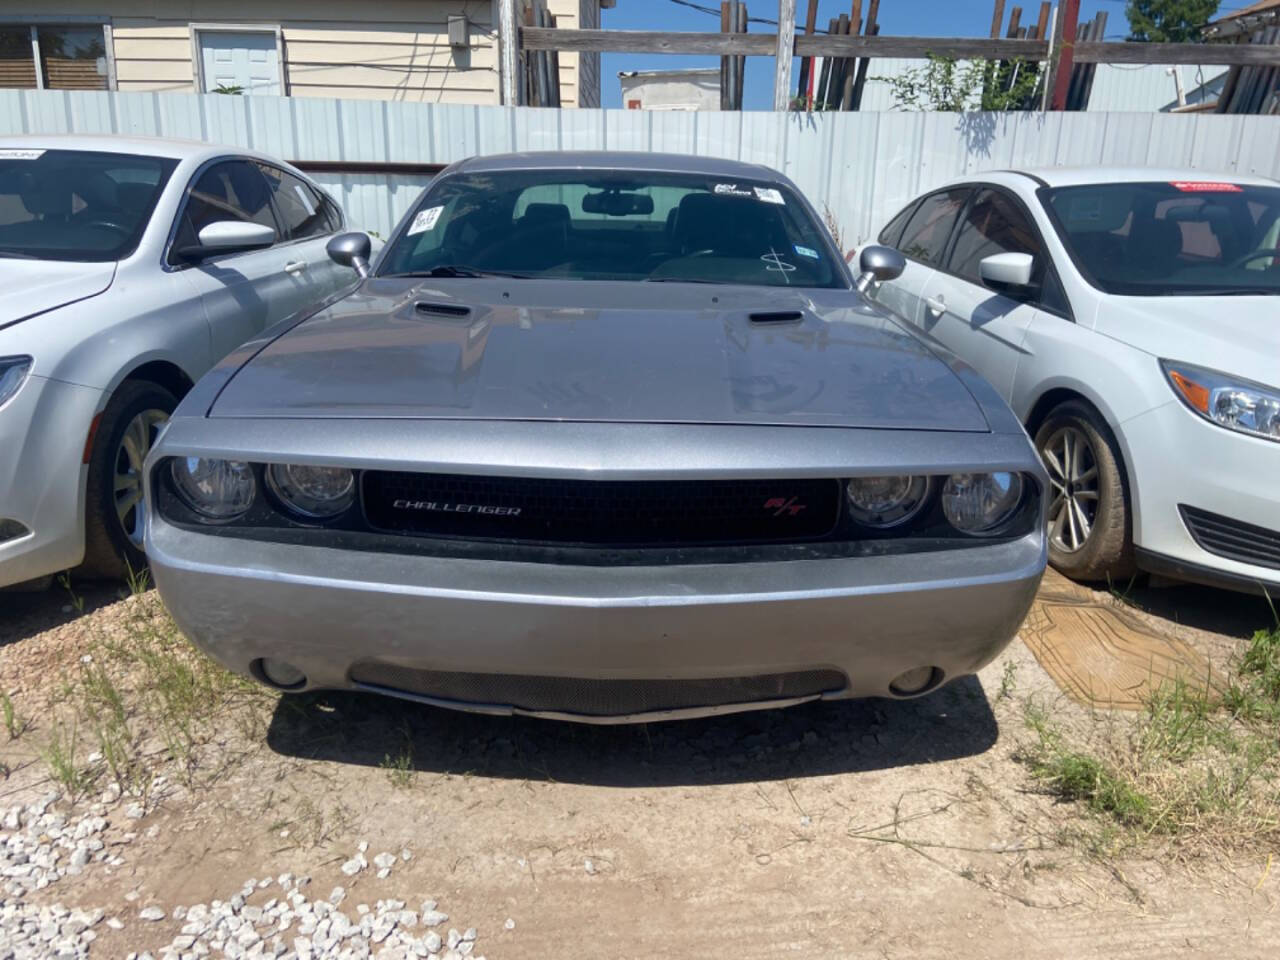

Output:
xmin=169 ymin=157 xmax=300 ymax=361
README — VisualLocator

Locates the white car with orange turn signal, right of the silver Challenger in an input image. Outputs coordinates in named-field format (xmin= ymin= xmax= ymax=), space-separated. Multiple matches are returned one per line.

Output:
xmin=877 ymin=168 xmax=1280 ymax=594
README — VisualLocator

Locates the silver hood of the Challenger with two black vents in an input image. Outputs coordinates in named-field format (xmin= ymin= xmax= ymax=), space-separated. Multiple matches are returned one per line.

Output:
xmin=210 ymin=279 xmax=988 ymax=431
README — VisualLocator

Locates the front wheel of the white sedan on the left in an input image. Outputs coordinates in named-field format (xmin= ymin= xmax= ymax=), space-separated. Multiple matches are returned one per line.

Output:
xmin=77 ymin=380 xmax=178 ymax=580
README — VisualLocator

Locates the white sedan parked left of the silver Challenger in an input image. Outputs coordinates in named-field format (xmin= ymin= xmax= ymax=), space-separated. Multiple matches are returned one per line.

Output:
xmin=0 ymin=136 xmax=355 ymax=588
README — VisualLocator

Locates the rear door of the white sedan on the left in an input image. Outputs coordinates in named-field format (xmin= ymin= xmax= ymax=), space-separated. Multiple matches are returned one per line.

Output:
xmin=259 ymin=163 xmax=356 ymax=310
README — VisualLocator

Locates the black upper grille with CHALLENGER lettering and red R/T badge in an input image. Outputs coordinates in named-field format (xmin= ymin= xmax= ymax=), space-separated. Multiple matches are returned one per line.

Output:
xmin=364 ymin=471 xmax=840 ymax=547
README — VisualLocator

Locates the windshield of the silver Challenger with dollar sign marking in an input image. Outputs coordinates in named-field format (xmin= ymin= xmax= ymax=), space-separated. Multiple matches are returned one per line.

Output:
xmin=379 ymin=170 xmax=845 ymax=287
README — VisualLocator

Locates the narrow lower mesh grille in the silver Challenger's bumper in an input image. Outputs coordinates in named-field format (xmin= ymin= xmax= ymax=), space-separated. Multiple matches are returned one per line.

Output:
xmin=349 ymin=660 xmax=845 ymax=717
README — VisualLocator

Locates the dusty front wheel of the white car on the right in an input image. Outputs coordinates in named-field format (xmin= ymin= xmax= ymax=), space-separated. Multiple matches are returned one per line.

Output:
xmin=1036 ymin=401 xmax=1134 ymax=581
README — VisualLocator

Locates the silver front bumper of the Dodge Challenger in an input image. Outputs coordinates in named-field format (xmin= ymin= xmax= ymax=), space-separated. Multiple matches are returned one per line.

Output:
xmin=147 ymin=512 xmax=1046 ymax=723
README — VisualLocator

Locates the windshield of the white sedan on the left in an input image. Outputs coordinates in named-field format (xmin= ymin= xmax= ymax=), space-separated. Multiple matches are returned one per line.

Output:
xmin=0 ymin=147 xmax=178 ymax=261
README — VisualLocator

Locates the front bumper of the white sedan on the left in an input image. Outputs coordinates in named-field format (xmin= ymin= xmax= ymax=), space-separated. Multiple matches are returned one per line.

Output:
xmin=0 ymin=376 xmax=102 ymax=588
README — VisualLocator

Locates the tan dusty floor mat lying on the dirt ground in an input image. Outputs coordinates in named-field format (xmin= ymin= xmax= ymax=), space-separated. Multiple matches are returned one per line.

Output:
xmin=1021 ymin=570 xmax=1213 ymax=710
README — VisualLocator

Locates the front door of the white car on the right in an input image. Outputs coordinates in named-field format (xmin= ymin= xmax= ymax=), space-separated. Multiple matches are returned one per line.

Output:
xmin=920 ymin=187 xmax=1065 ymax=399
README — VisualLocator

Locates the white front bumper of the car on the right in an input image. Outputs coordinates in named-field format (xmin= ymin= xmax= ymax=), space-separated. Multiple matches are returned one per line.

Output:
xmin=1123 ymin=401 xmax=1280 ymax=595
